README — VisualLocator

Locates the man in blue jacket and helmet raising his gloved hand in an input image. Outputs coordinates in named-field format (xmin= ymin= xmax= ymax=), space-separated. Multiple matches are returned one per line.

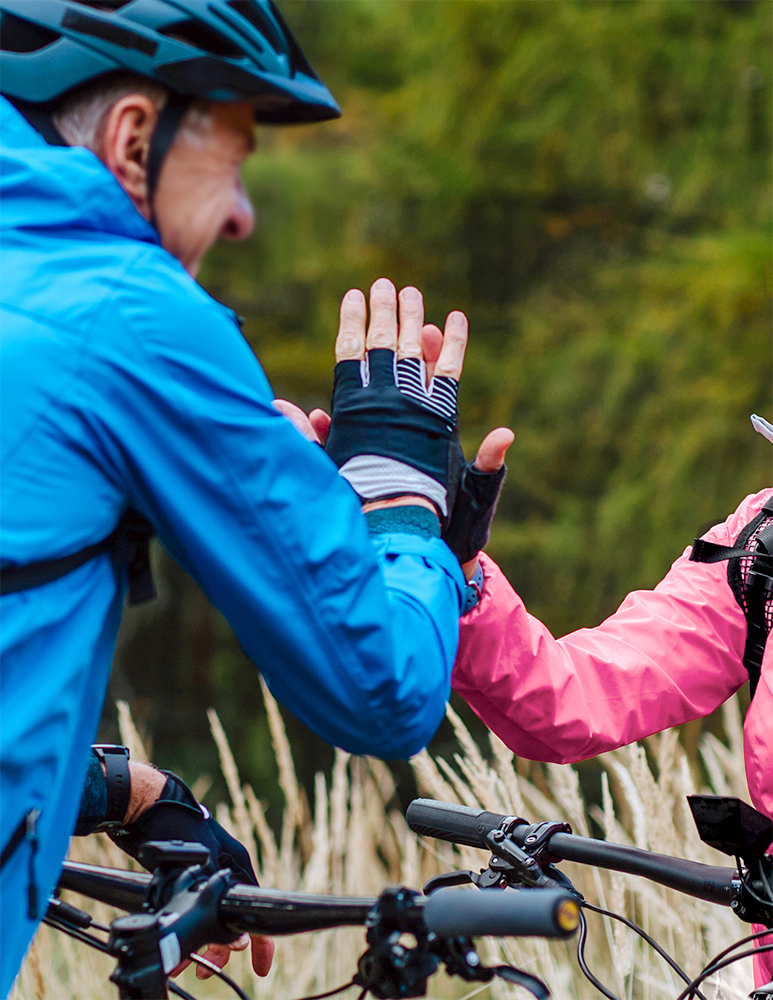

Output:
xmin=0 ymin=0 xmax=488 ymax=996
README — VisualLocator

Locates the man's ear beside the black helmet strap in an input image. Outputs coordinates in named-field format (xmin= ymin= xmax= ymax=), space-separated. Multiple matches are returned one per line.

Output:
xmin=102 ymin=94 xmax=158 ymax=219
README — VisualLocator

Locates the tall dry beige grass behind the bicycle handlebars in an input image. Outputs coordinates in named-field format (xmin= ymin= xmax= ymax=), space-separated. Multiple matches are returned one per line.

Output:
xmin=12 ymin=687 xmax=752 ymax=1000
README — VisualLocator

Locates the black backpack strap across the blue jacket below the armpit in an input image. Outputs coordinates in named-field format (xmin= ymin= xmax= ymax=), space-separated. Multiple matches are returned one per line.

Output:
xmin=0 ymin=510 xmax=156 ymax=604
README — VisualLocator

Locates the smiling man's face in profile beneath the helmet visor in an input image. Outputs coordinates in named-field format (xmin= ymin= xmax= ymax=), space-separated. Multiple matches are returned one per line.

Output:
xmin=155 ymin=101 xmax=255 ymax=277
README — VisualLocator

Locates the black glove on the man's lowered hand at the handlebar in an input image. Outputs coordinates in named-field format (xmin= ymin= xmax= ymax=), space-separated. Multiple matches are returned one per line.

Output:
xmin=108 ymin=771 xmax=258 ymax=885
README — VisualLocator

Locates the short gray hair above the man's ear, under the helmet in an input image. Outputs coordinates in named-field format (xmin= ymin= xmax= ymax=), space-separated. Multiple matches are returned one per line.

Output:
xmin=54 ymin=73 xmax=169 ymax=156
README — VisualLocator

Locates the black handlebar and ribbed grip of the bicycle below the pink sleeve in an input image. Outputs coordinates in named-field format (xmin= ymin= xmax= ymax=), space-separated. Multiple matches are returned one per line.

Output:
xmin=406 ymin=799 xmax=740 ymax=906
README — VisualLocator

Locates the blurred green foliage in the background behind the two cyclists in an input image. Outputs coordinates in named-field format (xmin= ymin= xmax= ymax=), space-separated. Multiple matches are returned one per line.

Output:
xmin=107 ymin=0 xmax=773 ymax=820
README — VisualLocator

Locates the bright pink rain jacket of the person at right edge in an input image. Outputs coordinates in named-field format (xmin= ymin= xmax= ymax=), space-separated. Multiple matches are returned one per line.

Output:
xmin=453 ymin=489 xmax=773 ymax=985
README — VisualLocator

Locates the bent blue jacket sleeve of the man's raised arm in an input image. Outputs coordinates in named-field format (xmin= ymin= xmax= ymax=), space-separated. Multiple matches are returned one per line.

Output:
xmin=83 ymin=252 xmax=464 ymax=758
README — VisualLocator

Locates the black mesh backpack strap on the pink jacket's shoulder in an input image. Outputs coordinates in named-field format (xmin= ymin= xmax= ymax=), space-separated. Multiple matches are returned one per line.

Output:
xmin=690 ymin=504 xmax=773 ymax=698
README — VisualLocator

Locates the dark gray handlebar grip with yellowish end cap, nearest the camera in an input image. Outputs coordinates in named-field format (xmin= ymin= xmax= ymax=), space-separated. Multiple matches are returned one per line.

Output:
xmin=424 ymin=889 xmax=580 ymax=938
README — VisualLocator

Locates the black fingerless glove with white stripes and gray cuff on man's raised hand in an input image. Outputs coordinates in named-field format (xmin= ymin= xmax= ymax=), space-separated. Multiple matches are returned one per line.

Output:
xmin=325 ymin=348 xmax=461 ymax=523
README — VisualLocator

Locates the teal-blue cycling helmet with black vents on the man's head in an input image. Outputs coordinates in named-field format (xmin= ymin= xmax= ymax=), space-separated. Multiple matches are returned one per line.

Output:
xmin=0 ymin=0 xmax=341 ymax=125
